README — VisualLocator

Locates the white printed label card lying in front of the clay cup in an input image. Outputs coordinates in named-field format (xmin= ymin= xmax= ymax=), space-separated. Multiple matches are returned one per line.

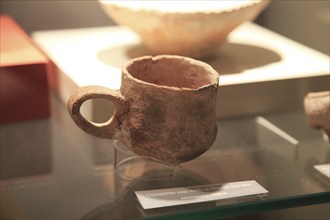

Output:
xmin=135 ymin=180 xmax=268 ymax=209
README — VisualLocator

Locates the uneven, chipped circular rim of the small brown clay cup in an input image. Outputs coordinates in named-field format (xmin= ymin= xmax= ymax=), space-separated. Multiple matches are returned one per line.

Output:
xmin=122 ymin=55 xmax=219 ymax=91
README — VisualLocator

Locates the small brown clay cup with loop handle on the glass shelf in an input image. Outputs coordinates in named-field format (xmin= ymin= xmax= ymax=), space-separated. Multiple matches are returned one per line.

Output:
xmin=68 ymin=55 xmax=219 ymax=164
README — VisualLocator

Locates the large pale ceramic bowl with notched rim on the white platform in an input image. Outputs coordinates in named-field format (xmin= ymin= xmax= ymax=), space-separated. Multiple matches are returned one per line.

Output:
xmin=99 ymin=0 xmax=269 ymax=58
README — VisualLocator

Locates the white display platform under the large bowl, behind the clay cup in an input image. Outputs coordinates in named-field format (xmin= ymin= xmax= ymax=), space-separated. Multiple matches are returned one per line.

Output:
xmin=32 ymin=22 xmax=330 ymax=121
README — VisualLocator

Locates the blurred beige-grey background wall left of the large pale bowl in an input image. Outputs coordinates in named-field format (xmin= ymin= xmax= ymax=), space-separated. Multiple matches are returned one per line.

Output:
xmin=0 ymin=0 xmax=114 ymax=32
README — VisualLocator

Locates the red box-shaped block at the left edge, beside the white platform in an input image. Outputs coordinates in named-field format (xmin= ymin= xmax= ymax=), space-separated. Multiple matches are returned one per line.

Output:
xmin=0 ymin=15 xmax=50 ymax=123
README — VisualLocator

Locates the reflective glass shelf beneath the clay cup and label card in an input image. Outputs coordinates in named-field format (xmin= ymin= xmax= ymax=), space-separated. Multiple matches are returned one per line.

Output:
xmin=0 ymin=97 xmax=330 ymax=220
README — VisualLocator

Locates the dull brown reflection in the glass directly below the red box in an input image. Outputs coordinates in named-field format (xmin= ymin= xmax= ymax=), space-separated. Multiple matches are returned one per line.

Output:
xmin=0 ymin=120 xmax=52 ymax=180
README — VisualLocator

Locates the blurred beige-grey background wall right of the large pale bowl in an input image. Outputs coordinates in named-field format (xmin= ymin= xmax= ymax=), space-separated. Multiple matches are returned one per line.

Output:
xmin=262 ymin=0 xmax=330 ymax=55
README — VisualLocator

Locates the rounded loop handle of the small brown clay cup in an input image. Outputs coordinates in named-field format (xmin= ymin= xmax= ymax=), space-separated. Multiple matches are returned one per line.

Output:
xmin=67 ymin=86 xmax=128 ymax=139
